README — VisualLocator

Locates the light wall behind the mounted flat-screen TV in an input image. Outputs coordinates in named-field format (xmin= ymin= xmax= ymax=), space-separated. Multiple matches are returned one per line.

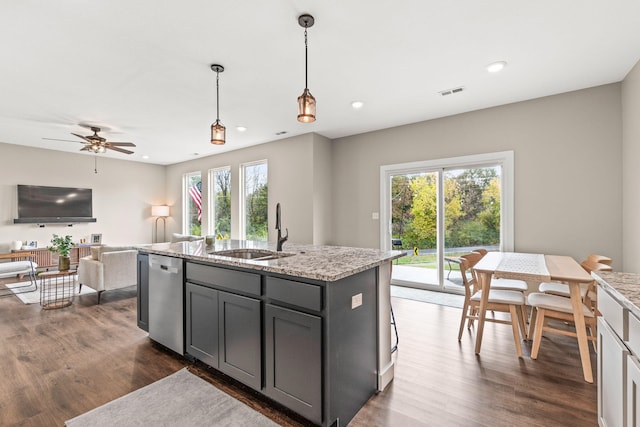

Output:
xmin=0 ymin=143 xmax=165 ymax=253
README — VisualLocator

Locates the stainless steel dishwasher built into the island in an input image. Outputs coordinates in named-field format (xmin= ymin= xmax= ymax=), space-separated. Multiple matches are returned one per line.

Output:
xmin=149 ymin=254 xmax=184 ymax=355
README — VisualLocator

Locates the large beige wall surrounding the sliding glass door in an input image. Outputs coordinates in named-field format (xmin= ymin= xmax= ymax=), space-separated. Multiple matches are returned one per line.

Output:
xmin=332 ymin=84 xmax=620 ymax=268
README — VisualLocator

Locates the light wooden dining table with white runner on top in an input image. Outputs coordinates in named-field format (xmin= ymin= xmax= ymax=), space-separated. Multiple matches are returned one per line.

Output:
xmin=474 ymin=252 xmax=593 ymax=383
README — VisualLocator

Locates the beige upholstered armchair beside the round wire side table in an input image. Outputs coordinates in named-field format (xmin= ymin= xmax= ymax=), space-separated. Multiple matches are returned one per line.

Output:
xmin=78 ymin=245 xmax=138 ymax=304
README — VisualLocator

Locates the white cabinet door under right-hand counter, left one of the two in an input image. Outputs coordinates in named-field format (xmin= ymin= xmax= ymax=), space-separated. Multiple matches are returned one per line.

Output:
xmin=598 ymin=317 xmax=629 ymax=426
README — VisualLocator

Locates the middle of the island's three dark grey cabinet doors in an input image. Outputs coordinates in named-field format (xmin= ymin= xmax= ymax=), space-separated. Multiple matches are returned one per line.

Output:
xmin=218 ymin=291 xmax=262 ymax=390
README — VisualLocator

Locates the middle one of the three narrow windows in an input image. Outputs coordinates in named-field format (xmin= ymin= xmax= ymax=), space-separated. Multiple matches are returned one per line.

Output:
xmin=209 ymin=167 xmax=231 ymax=240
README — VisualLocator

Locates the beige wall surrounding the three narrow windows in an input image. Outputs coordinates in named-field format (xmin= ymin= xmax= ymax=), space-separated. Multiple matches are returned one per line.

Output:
xmin=166 ymin=134 xmax=330 ymax=243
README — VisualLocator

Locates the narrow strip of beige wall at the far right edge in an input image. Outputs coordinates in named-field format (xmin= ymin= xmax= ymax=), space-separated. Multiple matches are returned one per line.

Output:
xmin=622 ymin=62 xmax=640 ymax=273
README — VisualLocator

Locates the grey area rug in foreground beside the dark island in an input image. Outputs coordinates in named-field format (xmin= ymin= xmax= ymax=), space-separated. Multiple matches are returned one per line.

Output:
xmin=65 ymin=368 xmax=278 ymax=427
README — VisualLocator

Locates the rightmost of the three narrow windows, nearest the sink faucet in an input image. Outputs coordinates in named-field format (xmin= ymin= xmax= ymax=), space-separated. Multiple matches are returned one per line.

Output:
xmin=240 ymin=160 xmax=269 ymax=242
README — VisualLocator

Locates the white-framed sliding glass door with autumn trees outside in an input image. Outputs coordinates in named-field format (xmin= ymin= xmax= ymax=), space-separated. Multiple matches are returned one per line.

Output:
xmin=380 ymin=152 xmax=513 ymax=293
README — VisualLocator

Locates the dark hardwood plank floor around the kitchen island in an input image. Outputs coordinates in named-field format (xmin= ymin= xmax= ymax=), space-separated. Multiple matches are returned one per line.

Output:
xmin=0 ymin=280 xmax=597 ymax=427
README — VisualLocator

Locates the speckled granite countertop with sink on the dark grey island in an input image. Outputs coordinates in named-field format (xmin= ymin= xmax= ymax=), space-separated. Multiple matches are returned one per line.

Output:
xmin=137 ymin=240 xmax=405 ymax=282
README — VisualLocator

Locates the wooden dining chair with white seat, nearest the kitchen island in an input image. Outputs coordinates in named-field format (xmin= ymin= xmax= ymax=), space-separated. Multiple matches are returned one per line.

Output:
xmin=458 ymin=254 xmax=526 ymax=357
